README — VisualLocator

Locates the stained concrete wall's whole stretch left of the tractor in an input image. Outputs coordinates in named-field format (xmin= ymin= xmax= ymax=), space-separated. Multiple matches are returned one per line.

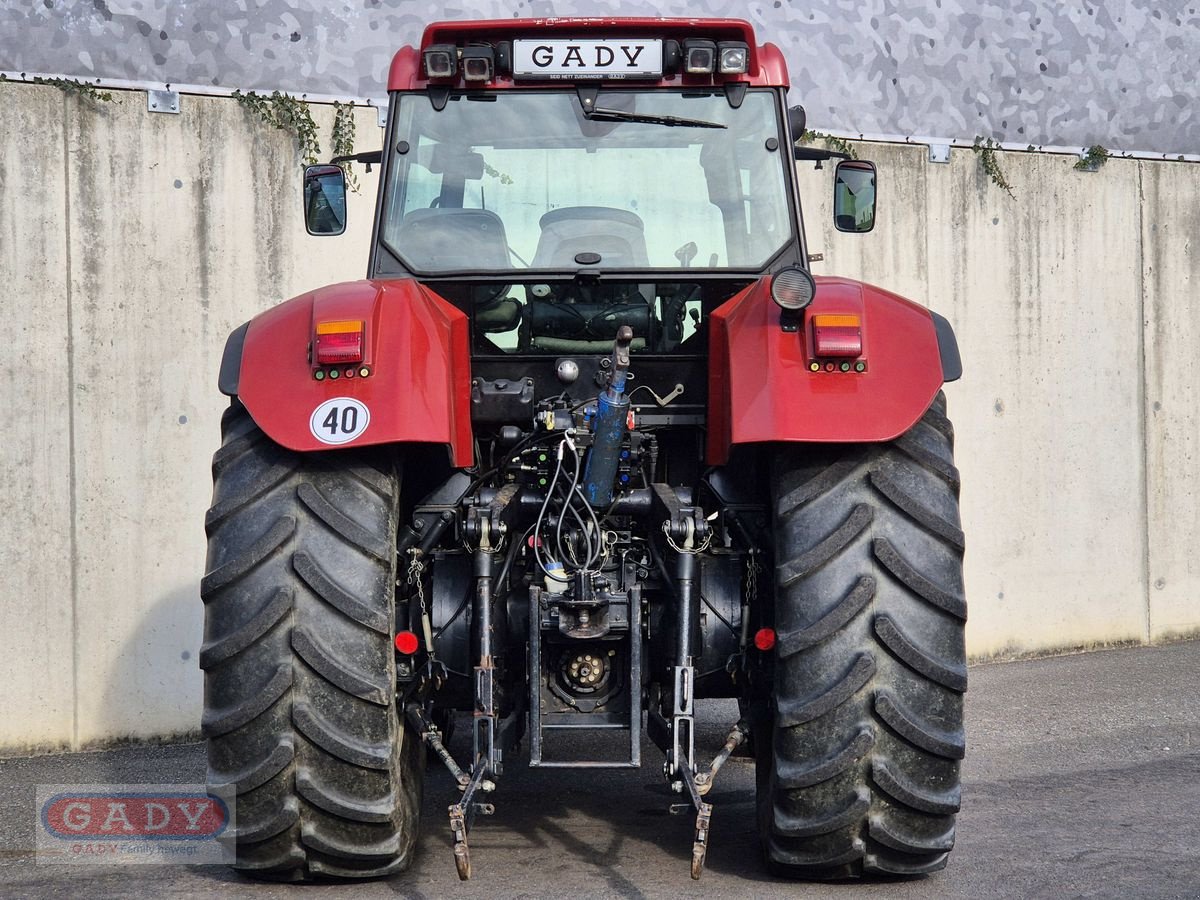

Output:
xmin=0 ymin=84 xmax=380 ymax=746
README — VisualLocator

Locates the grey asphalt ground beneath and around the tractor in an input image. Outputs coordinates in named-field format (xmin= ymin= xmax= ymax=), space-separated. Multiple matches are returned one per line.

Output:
xmin=0 ymin=642 xmax=1200 ymax=900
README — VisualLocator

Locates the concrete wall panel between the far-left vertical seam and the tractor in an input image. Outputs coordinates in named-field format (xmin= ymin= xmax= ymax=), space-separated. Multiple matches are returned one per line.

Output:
xmin=57 ymin=94 xmax=378 ymax=744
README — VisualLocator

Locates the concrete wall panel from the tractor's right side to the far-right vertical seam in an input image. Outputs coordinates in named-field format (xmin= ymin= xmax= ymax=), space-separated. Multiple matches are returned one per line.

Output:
xmin=802 ymin=145 xmax=1146 ymax=655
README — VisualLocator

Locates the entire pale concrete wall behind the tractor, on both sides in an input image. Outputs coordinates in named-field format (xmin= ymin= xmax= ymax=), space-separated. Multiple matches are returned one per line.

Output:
xmin=0 ymin=84 xmax=1200 ymax=748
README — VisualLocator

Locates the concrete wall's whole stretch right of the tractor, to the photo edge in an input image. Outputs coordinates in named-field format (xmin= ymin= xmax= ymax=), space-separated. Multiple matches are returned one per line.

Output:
xmin=802 ymin=145 xmax=1180 ymax=656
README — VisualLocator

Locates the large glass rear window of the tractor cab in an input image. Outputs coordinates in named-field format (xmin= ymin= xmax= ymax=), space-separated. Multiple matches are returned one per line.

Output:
xmin=382 ymin=90 xmax=793 ymax=275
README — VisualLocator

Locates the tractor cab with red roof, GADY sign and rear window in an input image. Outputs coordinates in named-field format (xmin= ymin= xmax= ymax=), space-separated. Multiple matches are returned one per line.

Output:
xmin=310 ymin=19 xmax=874 ymax=355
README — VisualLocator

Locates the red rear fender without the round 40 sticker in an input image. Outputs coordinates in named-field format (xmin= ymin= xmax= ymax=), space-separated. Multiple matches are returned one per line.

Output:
xmin=706 ymin=277 xmax=943 ymax=466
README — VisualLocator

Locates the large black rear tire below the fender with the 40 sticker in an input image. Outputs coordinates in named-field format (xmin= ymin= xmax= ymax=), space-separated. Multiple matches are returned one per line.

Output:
xmin=200 ymin=401 xmax=425 ymax=881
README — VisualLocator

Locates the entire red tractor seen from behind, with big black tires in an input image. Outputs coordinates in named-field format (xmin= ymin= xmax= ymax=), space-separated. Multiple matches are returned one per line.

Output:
xmin=200 ymin=18 xmax=966 ymax=880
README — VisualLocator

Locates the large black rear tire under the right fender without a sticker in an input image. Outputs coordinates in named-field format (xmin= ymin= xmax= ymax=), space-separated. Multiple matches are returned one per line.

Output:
xmin=758 ymin=394 xmax=967 ymax=880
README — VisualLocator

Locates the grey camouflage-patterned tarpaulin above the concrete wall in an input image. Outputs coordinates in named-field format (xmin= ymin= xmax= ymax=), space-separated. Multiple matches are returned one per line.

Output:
xmin=0 ymin=0 xmax=1200 ymax=154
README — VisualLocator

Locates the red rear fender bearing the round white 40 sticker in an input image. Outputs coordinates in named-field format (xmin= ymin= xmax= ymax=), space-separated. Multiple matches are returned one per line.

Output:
xmin=236 ymin=280 xmax=473 ymax=467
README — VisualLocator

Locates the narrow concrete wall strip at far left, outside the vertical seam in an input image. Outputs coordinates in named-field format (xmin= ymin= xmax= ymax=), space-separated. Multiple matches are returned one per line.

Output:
xmin=0 ymin=85 xmax=74 ymax=746
